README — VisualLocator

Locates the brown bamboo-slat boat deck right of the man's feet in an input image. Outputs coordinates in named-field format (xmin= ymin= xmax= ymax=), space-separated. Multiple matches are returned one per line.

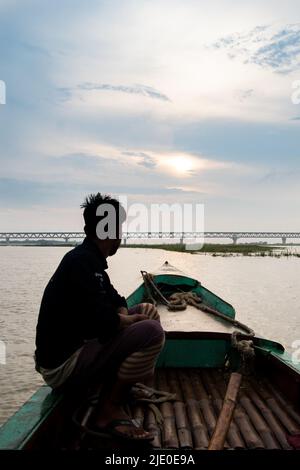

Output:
xmin=119 ymin=369 xmax=300 ymax=449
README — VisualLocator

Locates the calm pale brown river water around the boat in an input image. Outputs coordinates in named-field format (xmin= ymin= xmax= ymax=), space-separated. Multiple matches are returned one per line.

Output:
xmin=0 ymin=246 xmax=300 ymax=424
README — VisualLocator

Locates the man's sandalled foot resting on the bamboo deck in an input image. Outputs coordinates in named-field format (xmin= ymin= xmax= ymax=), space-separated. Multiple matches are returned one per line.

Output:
xmin=95 ymin=404 xmax=151 ymax=440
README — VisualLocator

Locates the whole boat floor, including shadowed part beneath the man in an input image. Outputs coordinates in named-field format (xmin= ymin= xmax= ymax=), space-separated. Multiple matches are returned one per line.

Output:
xmin=20 ymin=368 xmax=300 ymax=450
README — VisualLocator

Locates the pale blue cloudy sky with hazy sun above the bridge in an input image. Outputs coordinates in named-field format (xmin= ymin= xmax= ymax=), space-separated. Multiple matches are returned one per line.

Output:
xmin=0 ymin=0 xmax=300 ymax=231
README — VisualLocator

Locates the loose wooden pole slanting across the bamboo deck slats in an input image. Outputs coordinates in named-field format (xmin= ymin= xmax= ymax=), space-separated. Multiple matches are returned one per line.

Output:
xmin=208 ymin=372 xmax=242 ymax=450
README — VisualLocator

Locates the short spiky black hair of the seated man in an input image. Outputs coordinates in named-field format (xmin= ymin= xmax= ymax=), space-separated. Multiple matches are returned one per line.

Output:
xmin=80 ymin=193 xmax=126 ymax=238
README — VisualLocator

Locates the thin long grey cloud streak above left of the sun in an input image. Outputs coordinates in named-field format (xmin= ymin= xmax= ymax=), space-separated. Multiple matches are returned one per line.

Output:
xmin=77 ymin=82 xmax=171 ymax=101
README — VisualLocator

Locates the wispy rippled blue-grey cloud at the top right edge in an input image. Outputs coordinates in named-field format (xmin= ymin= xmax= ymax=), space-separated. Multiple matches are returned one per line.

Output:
xmin=212 ymin=23 xmax=300 ymax=74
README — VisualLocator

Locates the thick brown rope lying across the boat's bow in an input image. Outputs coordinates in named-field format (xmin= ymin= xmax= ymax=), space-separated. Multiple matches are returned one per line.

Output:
xmin=141 ymin=271 xmax=255 ymax=343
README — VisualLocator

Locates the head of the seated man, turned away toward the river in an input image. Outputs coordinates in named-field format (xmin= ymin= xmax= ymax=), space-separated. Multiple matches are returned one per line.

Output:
xmin=81 ymin=193 xmax=126 ymax=256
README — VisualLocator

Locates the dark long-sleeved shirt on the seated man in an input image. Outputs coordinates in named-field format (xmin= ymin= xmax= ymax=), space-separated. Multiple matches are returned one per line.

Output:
xmin=36 ymin=238 xmax=127 ymax=369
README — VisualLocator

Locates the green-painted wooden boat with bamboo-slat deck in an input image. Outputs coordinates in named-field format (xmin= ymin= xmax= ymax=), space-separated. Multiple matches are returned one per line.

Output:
xmin=0 ymin=262 xmax=300 ymax=449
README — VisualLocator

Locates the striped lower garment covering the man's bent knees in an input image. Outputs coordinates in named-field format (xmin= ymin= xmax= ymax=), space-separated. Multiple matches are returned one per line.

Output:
xmin=60 ymin=303 xmax=165 ymax=388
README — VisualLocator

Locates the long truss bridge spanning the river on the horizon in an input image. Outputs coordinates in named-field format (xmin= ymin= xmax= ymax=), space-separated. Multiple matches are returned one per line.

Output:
xmin=0 ymin=232 xmax=300 ymax=245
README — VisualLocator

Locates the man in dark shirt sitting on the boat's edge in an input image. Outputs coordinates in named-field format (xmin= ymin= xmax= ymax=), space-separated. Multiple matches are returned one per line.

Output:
xmin=35 ymin=193 xmax=164 ymax=440
